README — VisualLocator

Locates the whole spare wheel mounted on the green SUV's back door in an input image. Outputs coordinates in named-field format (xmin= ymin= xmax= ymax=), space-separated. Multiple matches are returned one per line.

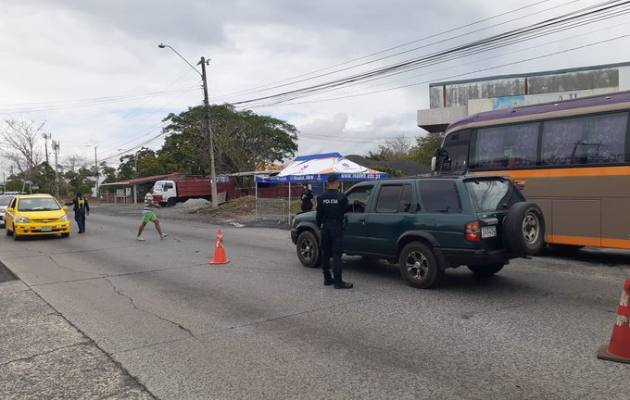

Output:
xmin=503 ymin=201 xmax=545 ymax=256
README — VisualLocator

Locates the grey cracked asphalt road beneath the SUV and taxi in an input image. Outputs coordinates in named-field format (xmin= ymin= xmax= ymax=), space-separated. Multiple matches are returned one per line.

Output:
xmin=0 ymin=211 xmax=630 ymax=400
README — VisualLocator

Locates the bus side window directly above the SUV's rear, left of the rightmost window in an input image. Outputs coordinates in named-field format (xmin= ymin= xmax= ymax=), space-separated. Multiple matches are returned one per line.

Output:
xmin=471 ymin=122 xmax=540 ymax=169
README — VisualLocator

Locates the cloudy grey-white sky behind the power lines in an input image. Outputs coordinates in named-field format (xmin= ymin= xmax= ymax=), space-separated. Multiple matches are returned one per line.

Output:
xmin=0 ymin=0 xmax=630 ymax=167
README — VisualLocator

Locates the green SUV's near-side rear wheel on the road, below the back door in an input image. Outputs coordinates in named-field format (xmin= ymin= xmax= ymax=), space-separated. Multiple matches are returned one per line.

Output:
xmin=399 ymin=242 xmax=444 ymax=289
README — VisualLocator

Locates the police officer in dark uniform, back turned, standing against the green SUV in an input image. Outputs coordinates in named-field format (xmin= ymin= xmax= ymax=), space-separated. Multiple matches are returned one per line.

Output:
xmin=316 ymin=174 xmax=353 ymax=289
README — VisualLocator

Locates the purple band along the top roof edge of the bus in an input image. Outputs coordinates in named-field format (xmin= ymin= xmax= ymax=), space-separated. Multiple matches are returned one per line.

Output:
xmin=447 ymin=91 xmax=630 ymax=131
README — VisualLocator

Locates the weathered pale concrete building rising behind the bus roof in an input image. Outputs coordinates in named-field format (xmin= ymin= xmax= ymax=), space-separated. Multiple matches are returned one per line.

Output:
xmin=418 ymin=62 xmax=630 ymax=132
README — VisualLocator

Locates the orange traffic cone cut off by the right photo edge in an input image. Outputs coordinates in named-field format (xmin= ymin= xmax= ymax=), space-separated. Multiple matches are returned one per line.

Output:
xmin=597 ymin=279 xmax=630 ymax=364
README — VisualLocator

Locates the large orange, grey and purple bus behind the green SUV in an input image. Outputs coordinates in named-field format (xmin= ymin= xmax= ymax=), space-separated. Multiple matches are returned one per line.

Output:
xmin=432 ymin=92 xmax=630 ymax=250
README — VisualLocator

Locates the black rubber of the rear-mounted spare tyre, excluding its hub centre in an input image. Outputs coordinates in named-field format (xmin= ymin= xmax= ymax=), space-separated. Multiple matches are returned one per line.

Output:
xmin=503 ymin=201 xmax=545 ymax=257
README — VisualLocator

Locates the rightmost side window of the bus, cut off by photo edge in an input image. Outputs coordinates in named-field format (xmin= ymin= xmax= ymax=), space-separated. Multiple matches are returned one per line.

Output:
xmin=542 ymin=112 xmax=628 ymax=165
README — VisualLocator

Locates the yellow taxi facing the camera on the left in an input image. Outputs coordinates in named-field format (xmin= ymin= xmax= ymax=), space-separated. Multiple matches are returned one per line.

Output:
xmin=4 ymin=194 xmax=70 ymax=240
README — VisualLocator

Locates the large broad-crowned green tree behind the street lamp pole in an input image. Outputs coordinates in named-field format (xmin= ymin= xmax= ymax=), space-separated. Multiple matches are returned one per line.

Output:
xmin=158 ymin=104 xmax=297 ymax=175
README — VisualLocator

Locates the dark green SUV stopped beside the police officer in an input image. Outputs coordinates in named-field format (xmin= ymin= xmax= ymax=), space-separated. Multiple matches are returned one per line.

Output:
xmin=291 ymin=176 xmax=545 ymax=288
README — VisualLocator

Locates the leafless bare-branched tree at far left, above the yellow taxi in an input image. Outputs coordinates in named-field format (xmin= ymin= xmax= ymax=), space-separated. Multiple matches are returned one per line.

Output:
xmin=0 ymin=120 xmax=45 ymax=179
